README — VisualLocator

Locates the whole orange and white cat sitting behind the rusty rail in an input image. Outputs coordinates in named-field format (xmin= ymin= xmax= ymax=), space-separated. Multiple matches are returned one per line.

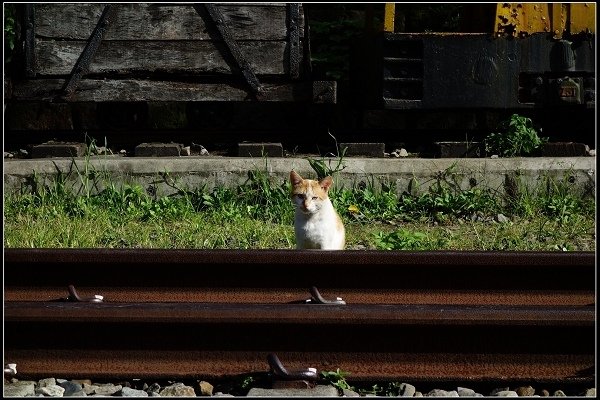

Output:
xmin=290 ymin=171 xmax=346 ymax=250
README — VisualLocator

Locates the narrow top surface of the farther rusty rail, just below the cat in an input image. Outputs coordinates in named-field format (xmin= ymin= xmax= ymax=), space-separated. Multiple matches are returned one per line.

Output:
xmin=4 ymin=249 xmax=594 ymax=267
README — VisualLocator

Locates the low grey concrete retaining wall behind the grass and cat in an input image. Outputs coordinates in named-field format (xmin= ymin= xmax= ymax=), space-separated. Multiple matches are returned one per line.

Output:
xmin=4 ymin=156 xmax=596 ymax=200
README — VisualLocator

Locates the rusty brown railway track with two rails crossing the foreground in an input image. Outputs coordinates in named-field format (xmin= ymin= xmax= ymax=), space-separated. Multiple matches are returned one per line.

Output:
xmin=4 ymin=249 xmax=596 ymax=390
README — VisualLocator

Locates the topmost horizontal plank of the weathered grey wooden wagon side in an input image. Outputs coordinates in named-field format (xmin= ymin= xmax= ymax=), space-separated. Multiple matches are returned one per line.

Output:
xmin=35 ymin=3 xmax=304 ymax=41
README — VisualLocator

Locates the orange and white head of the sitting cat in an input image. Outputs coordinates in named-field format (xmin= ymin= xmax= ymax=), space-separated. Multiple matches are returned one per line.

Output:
xmin=290 ymin=170 xmax=333 ymax=214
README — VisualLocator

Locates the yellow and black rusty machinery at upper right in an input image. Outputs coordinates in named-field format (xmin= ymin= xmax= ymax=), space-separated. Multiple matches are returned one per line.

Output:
xmin=375 ymin=3 xmax=596 ymax=109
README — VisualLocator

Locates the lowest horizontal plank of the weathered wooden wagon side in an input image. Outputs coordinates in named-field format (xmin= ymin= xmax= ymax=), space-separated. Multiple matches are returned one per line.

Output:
xmin=13 ymin=79 xmax=312 ymax=102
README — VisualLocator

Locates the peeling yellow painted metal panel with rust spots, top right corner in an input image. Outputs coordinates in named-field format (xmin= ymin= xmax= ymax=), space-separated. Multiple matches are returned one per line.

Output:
xmin=494 ymin=3 xmax=596 ymax=38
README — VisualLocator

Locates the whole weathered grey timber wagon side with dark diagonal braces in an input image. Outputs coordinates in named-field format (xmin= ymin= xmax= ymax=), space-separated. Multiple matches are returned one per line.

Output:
xmin=10 ymin=3 xmax=336 ymax=103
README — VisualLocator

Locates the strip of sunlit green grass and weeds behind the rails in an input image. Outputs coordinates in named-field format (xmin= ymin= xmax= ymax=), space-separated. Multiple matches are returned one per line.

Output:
xmin=4 ymin=161 xmax=595 ymax=251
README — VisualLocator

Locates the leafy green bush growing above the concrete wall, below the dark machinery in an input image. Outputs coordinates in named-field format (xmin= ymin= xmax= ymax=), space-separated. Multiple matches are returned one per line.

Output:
xmin=484 ymin=114 xmax=548 ymax=157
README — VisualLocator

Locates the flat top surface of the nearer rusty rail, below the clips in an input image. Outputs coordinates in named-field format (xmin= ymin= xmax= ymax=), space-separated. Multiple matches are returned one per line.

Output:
xmin=4 ymin=302 xmax=595 ymax=327
